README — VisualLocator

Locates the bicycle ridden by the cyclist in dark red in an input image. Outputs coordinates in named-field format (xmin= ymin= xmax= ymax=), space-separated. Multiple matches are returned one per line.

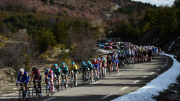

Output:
xmin=32 ymin=80 xmax=41 ymax=98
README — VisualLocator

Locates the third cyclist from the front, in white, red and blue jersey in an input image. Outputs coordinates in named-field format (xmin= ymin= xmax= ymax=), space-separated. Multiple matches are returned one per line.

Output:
xmin=44 ymin=68 xmax=54 ymax=92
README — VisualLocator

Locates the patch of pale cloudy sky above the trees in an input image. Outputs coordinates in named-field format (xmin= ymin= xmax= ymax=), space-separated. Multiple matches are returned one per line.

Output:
xmin=132 ymin=0 xmax=175 ymax=6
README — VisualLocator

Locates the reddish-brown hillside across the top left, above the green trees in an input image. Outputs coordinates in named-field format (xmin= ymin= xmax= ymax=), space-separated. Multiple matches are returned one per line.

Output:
xmin=0 ymin=0 xmax=114 ymax=20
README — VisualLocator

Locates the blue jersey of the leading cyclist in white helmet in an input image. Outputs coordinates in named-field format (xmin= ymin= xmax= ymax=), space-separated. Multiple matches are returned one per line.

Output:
xmin=17 ymin=71 xmax=29 ymax=84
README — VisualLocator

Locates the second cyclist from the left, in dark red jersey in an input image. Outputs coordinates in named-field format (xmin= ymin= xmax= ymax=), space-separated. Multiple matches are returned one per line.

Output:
xmin=30 ymin=67 xmax=42 ymax=96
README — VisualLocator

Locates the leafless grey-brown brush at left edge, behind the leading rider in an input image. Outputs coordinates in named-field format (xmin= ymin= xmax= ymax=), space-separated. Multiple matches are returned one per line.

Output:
xmin=0 ymin=37 xmax=36 ymax=82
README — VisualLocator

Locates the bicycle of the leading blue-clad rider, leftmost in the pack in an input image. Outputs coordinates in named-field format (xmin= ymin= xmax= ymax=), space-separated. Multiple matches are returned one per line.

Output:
xmin=16 ymin=83 xmax=30 ymax=101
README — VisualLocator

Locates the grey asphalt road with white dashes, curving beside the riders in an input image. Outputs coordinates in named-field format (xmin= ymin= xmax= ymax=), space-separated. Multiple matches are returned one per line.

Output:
xmin=0 ymin=53 xmax=173 ymax=101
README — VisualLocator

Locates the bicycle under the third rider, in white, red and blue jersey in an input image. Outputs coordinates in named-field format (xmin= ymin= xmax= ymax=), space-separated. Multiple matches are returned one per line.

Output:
xmin=46 ymin=79 xmax=54 ymax=96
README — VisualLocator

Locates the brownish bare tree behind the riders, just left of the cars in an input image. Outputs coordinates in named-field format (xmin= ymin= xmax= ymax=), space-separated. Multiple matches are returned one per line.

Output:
xmin=69 ymin=28 xmax=96 ymax=62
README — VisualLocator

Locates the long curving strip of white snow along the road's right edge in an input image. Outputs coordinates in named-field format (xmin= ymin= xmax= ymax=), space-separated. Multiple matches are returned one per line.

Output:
xmin=112 ymin=53 xmax=180 ymax=101
